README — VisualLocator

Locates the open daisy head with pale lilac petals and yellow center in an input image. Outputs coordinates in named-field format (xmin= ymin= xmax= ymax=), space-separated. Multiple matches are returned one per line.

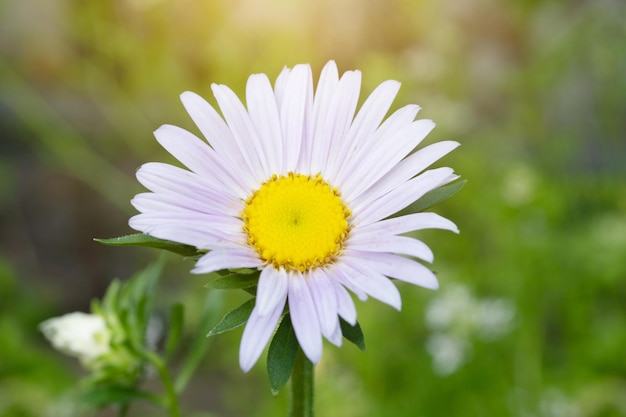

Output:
xmin=130 ymin=61 xmax=458 ymax=372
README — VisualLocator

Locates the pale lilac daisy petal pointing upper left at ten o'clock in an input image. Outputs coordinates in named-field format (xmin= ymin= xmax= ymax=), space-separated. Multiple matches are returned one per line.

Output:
xmin=154 ymin=125 xmax=247 ymax=198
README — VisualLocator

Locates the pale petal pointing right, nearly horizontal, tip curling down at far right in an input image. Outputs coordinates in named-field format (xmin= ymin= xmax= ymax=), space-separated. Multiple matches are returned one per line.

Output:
xmin=350 ymin=213 xmax=459 ymax=238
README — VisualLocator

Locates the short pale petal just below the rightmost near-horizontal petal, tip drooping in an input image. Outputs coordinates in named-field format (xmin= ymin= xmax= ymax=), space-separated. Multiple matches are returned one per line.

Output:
xmin=347 ymin=235 xmax=433 ymax=262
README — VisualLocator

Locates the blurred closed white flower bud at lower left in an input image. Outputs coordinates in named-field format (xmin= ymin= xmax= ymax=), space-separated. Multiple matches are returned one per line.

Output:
xmin=39 ymin=312 xmax=111 ymax=367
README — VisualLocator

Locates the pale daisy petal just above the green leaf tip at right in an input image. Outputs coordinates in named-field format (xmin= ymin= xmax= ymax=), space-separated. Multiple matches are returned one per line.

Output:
xmin=352 ymin=168 xmax=455 ymax=225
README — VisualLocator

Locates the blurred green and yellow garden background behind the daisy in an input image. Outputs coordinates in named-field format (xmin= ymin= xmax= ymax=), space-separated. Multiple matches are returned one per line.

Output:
xmin=0 ymin=0 xmax=626 ymax=417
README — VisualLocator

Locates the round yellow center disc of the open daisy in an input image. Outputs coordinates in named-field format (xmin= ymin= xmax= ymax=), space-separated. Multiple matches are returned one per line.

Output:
xmin=241 ymin=172 xmax=350 ymax=272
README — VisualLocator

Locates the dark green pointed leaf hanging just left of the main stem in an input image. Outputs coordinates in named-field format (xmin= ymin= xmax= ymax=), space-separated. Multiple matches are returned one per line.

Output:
xmin=267 ymin=314 xmax=298 ymax=395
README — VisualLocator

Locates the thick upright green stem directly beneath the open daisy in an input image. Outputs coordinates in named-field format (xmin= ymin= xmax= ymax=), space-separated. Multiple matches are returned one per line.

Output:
xmin=289 ymin=348 xmax=313 ymax=417
